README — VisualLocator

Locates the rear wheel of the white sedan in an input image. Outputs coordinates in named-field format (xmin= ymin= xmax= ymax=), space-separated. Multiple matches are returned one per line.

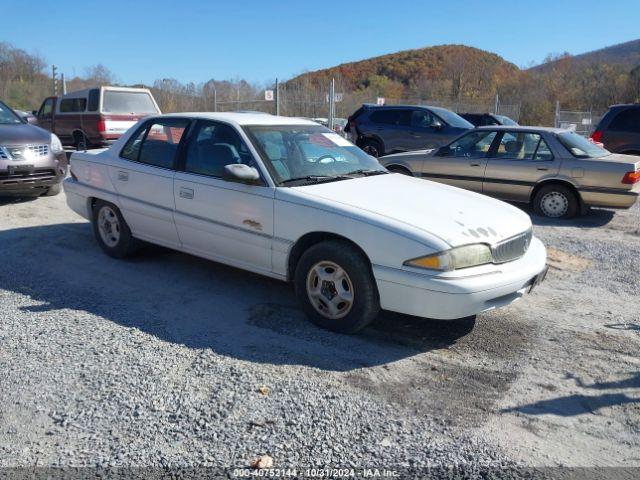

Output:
xmin=92 ymin=200 xmax=140 ymax=258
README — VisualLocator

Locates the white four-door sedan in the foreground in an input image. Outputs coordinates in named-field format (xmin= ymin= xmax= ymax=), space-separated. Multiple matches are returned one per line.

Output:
xmin=64 ymin=113 xmax=546 ymax=333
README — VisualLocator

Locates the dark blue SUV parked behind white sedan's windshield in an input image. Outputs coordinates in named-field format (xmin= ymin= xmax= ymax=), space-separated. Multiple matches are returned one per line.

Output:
xmin=344 ymin=105 xmax=473 ymax=157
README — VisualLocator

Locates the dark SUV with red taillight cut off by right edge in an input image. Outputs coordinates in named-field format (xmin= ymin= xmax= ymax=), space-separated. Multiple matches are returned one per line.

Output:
xmin=591 ymin=103 xmax=640 ymax=155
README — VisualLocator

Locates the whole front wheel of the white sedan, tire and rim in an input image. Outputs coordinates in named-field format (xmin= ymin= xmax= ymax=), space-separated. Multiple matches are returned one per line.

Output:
xmin=294 ymin=240 xmax=380 ymax=333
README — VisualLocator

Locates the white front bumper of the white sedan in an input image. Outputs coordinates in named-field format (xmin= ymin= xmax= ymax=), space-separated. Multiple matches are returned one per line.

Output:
xmin=373 ymin=237 xmax=547 ymax=320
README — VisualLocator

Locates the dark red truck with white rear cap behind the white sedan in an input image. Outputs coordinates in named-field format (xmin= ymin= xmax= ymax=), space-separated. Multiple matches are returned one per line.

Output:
xmin=37 ymin=87 xmax=160 ymax=150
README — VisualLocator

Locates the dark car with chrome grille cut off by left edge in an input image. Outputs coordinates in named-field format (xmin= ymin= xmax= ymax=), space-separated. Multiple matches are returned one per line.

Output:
xmin=0 ymin=101 xmax=67 ymax=196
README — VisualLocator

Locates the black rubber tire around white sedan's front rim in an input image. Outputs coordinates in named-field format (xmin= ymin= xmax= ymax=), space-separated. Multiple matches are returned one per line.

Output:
xmin=294 ymin=240 xmax=380 ymax=333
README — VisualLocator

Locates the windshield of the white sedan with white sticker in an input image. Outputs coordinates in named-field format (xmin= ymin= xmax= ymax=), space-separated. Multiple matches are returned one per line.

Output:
xmin=245 ymin=125 xmax=386 ymax=185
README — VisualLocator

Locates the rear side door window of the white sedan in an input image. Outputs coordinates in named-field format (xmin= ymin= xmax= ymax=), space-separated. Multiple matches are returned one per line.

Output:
xmin=120 ymin=119 xmax=189 ymax=168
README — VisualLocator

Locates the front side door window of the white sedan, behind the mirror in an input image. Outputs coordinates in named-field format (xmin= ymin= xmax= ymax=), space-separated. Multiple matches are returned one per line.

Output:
xmin=184 ymin=121 xmax=255 ymax=178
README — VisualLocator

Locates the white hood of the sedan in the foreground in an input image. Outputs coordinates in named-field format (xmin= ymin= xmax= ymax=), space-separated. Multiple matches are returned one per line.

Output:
xmin=289 ymin=174 xmax=531 ymax=247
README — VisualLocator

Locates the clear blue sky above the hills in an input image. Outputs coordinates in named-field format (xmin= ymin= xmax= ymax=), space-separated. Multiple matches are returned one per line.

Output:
xmin=0 ymin=0 xmax=640 ymax=84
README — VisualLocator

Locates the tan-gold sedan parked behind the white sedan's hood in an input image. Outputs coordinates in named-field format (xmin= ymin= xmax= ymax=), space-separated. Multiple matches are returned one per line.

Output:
xmin=380 ymin=126 xmax=640 ymax=218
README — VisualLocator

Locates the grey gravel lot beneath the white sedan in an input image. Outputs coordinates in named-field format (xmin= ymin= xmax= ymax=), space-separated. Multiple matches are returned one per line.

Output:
xmin=0 ymin=190 xmax=640 ymax=468
